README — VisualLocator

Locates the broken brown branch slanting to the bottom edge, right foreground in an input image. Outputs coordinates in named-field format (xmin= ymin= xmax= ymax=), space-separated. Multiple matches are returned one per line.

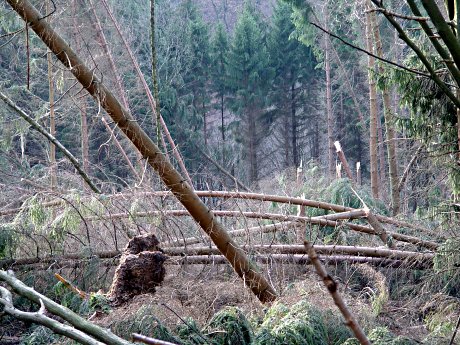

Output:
xmin=304 ymin=241 xmax=371 ymax=345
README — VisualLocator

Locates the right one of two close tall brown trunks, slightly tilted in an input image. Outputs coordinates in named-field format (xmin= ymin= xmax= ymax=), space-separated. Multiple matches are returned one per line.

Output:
xmin=372 ymin=13 xmax=400 ymax=215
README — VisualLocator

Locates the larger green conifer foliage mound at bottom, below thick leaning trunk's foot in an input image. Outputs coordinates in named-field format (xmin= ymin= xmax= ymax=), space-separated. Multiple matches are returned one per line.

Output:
xmin=254 ymin=301 xmax=328 ymax=345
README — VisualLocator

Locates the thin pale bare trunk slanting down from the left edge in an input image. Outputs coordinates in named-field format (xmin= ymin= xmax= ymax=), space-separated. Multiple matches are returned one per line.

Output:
xmin=0 ymin=92 xmax=101 ymax=194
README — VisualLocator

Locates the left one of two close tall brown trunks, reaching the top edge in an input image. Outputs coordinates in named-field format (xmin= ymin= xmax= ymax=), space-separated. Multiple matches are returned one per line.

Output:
xmin=365 ymin=0 xmax=379 ymax=199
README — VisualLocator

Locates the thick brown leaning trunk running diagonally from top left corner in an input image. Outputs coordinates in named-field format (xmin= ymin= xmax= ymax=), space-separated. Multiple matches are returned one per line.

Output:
xmin=7 ymin=0 xmax=276 ymax=302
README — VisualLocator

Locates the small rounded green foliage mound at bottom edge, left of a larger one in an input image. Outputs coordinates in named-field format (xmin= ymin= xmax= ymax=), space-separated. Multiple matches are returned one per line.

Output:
xmin=205 ymin=307 xmax=253 ymax=345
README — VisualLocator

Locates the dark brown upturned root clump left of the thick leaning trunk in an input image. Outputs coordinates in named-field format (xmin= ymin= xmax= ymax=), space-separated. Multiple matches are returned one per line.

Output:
xmin=109 ymin=234 xmax=166 ymax=305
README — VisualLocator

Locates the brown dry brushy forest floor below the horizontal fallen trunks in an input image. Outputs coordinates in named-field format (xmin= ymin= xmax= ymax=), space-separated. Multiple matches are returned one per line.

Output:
xmin=94 ymin=265 xmax=429 ymax=342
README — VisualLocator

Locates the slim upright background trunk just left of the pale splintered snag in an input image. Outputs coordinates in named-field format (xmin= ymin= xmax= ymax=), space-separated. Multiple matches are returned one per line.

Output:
xmin=324 ymin=16 xmax=335 ymax=179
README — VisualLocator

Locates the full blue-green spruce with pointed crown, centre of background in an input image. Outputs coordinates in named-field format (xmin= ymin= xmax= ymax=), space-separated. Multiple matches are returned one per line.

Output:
xmin=228 ymin=6 xmax=270 ymax=182
